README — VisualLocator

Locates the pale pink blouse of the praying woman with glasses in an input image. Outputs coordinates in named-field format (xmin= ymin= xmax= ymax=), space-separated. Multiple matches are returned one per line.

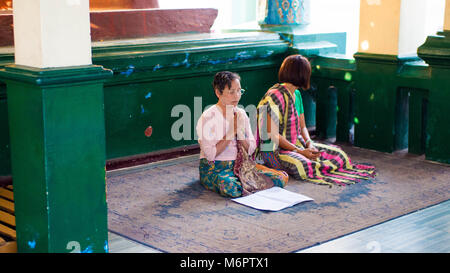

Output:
xmin=196 ymin=105 xmax=256 ymax=161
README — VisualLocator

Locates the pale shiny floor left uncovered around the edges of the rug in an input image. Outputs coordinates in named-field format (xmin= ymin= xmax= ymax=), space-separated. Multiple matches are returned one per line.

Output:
xmin=109 ymin=200 xmax=450 ymax=253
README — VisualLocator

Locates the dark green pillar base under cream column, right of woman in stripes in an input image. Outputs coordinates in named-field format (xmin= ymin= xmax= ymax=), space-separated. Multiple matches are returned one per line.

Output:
xmin=355 ymin=53 xmax=408 ymax=153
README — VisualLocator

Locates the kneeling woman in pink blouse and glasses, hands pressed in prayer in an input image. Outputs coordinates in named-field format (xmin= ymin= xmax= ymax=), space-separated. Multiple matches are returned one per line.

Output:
xmin=196 ymin=71 xmax=288 ymax=197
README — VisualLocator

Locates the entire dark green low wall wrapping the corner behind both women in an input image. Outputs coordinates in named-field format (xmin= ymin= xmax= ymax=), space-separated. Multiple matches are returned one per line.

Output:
xmin=0 ymin=30 xmax=450 ymax=176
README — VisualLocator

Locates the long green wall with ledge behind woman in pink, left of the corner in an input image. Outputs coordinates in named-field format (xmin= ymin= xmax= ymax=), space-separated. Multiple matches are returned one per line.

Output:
xmin=0 ymin=33 xmax=288 ymax=176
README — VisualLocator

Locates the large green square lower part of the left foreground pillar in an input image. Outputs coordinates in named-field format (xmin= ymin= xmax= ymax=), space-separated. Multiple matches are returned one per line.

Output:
xmin=0 ymin=65 xmax=112 ymax=252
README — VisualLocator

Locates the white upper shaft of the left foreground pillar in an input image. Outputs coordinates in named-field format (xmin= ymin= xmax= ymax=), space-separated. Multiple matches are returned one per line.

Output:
xmin=13 ymin=0 xmax=92 ymax=68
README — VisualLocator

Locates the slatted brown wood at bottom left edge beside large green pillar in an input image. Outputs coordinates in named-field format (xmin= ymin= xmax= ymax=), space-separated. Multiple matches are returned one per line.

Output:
xmin=0 ymin=185 xmax=17 ymax=253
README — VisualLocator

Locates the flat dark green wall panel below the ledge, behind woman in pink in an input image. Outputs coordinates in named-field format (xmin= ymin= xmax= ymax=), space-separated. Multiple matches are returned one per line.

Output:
xmin=105 ymin=67 xmax=276 ymax=158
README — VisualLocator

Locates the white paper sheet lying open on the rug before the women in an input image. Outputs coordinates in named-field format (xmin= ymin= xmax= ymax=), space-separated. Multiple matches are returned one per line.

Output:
xmin=231 ymin=187 xmax=313 ymax=211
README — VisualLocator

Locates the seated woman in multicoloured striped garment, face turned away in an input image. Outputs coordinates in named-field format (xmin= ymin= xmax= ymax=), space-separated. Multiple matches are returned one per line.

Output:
xmin=257 ymin=55 xmax=375 ymax=185
